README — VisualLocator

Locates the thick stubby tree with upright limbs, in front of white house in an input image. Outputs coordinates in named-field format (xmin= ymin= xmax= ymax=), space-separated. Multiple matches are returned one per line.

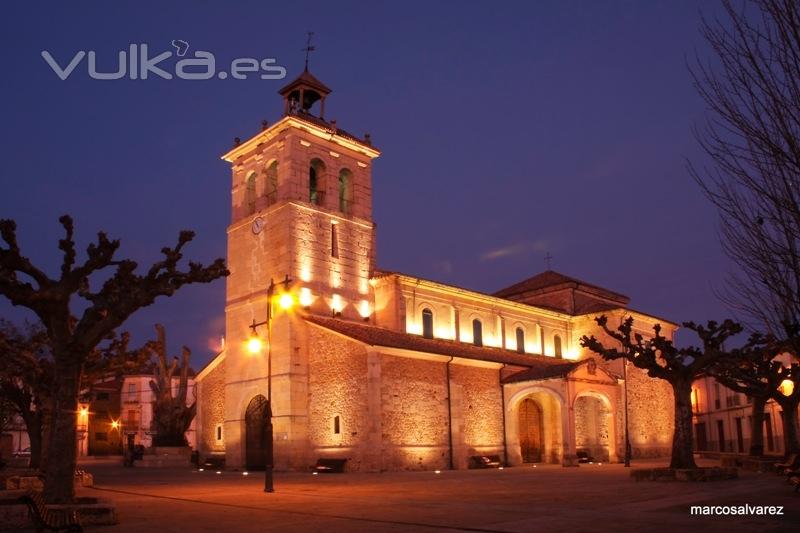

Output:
xmin=147 ymin=324 xmax=197 ymax=446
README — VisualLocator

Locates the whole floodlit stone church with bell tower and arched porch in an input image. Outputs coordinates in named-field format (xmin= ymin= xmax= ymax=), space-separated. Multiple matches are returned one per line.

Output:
xmin=197 ymin=70 xmax=677 ymax=471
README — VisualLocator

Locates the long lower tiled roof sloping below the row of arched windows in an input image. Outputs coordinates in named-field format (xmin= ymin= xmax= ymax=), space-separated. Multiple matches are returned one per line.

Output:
xmin=305 ymin=315 xmax=564 ymax=369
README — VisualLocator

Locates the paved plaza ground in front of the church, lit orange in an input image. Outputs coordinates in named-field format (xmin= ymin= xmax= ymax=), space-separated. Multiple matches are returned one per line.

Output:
xmin=18 ymin=463 xmax=800 ymax=533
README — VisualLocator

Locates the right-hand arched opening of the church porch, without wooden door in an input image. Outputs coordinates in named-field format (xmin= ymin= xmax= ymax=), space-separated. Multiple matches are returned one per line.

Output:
xmin=575 ymin=394 xmax=613 ymax=462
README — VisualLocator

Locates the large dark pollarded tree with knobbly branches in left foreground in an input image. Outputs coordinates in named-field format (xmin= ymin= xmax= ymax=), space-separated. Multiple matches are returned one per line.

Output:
xmin=0 ymin=216 xmax=228 ymax=503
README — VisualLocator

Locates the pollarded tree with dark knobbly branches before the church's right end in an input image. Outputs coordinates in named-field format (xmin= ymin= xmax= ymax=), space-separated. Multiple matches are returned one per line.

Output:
xmin=581 ymin=316 xmax=742 ymax=468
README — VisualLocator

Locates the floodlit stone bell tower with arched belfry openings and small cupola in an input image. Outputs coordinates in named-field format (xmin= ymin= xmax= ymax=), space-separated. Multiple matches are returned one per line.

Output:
xmin=222 ymin=70 xmax=380 ymax=468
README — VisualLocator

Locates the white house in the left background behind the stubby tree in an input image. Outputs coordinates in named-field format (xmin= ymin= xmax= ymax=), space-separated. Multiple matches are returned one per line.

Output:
xmin=120 ymin=374 xmax=197 ymax=449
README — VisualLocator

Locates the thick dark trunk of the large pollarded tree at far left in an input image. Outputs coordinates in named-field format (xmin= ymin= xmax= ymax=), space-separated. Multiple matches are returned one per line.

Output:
xmin=44 ymin=353 xmax=84 ymax=503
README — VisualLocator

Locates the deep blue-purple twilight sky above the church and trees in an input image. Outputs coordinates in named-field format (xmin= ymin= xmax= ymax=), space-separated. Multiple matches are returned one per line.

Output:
xmin=0 ymin=0 xmax=730 ymax=368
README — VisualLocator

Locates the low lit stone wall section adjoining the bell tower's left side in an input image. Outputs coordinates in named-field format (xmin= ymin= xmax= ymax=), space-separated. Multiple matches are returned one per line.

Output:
xmin=197 ymin=356 xmax=225 ymax=456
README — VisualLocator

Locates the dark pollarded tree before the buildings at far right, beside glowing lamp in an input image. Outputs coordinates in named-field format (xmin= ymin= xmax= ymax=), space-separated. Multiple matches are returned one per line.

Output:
xmin=708 ymin=333 xmax=784 ymax=456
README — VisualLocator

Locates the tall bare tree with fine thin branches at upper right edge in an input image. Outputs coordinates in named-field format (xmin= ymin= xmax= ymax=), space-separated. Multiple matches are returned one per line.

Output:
xmin=689 ymin=0 xmax=800 ymax=348
